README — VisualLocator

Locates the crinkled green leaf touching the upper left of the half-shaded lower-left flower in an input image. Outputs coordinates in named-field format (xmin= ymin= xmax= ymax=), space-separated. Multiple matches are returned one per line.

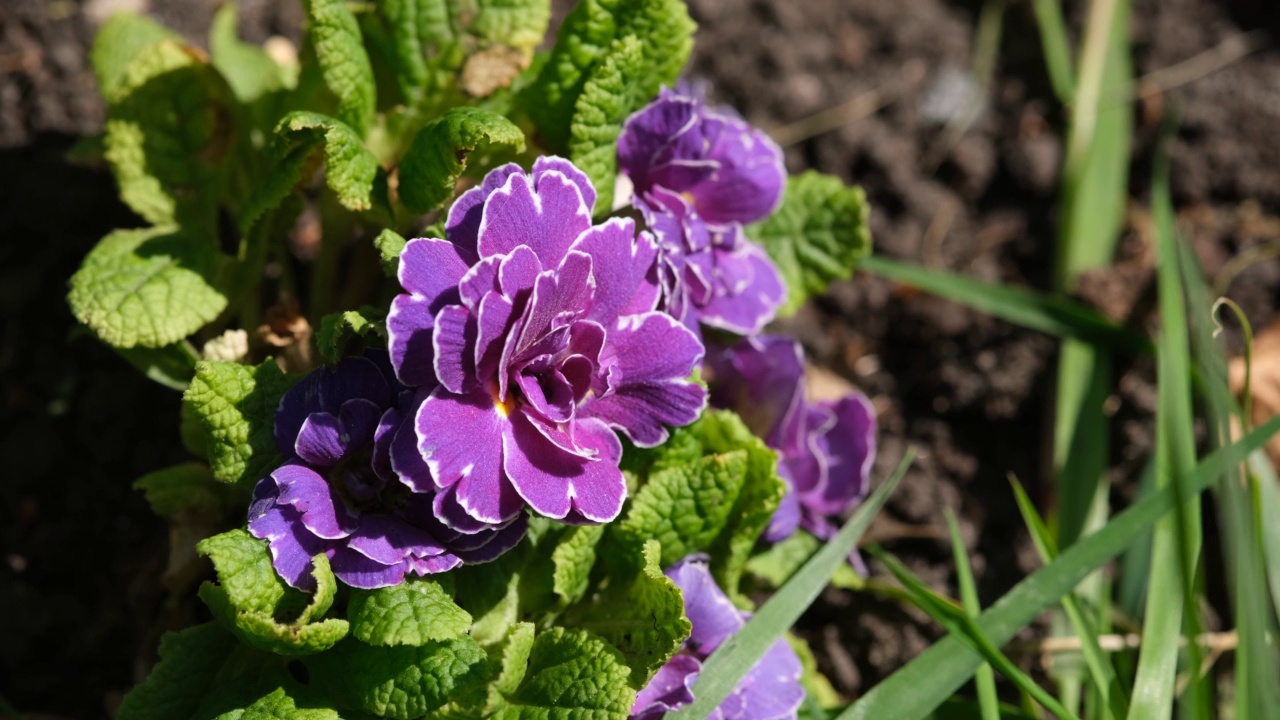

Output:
xmin=183 ymin=360 xmax=297 ymax=486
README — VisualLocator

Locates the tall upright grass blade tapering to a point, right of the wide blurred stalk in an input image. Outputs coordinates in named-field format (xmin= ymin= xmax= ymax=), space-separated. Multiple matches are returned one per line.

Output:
xmin=1129 ymin=107 xmax=1208 ymax=720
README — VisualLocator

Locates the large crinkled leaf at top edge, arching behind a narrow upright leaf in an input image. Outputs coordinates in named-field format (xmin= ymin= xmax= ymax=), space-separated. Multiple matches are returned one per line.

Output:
xmin=524 ymin=0 xmax=696 ymax=152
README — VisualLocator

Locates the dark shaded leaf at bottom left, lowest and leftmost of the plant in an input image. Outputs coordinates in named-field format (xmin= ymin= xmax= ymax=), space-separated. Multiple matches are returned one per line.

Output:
xmin=115 ymin=623 xmax=236 ymax=720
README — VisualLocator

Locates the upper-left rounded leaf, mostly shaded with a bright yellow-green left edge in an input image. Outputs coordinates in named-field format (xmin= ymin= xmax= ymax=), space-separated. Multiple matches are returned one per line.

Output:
xmin=104 ymin=40 xmax=234 ymax=224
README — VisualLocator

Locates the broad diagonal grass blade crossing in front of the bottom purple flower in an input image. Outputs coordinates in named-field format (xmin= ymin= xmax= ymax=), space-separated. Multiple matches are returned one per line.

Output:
xmin=668 ymin=447 xmax=915 ymax=720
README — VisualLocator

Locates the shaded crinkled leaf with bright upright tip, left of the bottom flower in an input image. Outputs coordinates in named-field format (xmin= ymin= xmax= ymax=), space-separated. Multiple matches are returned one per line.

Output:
xmin=564 ymin=539 xmax=691 ymax=691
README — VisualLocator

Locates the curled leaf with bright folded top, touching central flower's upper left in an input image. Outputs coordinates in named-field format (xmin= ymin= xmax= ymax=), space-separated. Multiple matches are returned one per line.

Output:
xmin=399 ymin=108 xmax=525 ymax=214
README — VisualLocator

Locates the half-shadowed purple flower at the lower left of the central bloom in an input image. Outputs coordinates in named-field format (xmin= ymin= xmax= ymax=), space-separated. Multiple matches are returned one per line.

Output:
xmin=248 ymin=354 xmax=529 ymax=589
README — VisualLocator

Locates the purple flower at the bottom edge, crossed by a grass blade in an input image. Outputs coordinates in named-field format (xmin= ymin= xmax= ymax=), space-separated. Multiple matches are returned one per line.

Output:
xmin=631 ymin=555 xmax=804 ymax=720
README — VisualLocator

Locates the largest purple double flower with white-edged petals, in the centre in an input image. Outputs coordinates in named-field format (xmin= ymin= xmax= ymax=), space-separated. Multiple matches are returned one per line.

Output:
xmin=387 ymin=158 xmax=707 ymax=532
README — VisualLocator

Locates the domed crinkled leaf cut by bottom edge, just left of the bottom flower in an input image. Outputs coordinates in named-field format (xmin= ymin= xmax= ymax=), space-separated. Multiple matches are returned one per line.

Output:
xmin=495 ymin=628 xmax=635 ymax=720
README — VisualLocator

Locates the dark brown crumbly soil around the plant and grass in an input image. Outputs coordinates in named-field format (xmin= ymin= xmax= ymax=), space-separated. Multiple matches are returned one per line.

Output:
xmin=0 ymin=0 xmax=1280 ymax=717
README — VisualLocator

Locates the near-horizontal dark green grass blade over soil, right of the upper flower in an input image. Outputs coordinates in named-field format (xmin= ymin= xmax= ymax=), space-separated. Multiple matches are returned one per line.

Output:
xmin=860 ymin=255 xmax=1151 ymax=352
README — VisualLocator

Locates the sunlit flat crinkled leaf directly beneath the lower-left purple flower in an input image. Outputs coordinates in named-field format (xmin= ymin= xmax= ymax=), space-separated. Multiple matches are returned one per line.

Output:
xmin=347 ymin=575 xmax=471 ymax=647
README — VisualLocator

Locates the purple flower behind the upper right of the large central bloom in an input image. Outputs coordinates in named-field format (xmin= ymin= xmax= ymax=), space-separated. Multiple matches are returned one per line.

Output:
xmin=618 ymin=88 xmax=786 ymax=334
